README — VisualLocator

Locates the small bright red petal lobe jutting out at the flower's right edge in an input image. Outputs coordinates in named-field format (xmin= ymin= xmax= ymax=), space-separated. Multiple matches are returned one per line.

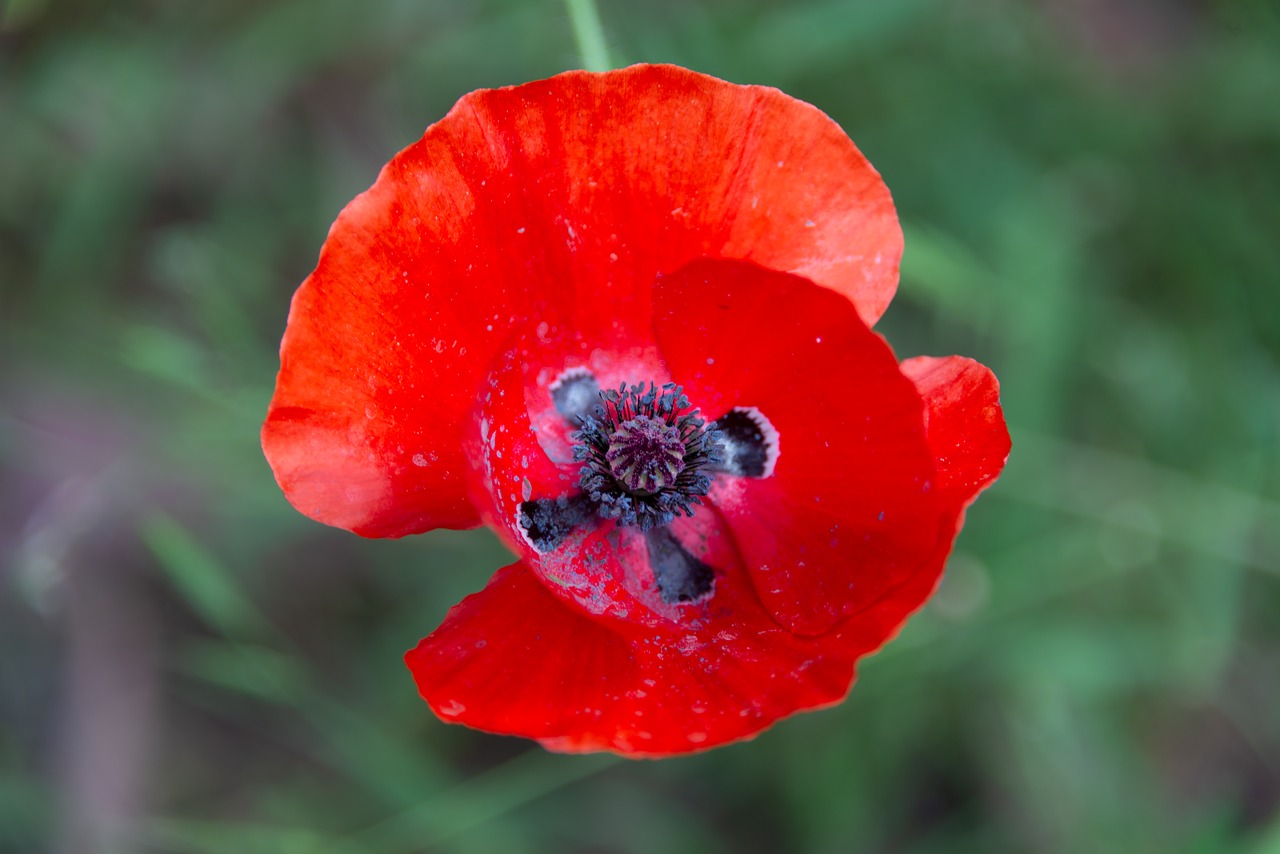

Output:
xmin=902 ymin=356 xmax=1010 ymax=507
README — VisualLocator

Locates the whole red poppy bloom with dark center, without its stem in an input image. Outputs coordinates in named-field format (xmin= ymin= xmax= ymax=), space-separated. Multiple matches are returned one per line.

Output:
xmin=262 ymin=65 xmax=1009 ymax=755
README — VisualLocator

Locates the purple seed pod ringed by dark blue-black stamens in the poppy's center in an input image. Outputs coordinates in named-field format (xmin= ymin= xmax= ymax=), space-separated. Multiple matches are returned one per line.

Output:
xmin=573 ymin=383 xmax=722 ymax=531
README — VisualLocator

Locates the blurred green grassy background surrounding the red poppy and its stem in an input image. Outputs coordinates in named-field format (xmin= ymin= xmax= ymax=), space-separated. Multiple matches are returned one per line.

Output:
xmin=0 ymin=0 xmax=1280 ymax=854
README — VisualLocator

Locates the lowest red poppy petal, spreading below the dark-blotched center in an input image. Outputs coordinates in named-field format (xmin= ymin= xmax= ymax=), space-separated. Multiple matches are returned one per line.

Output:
xmin=406 ymin=563 xmax=858 ymax=757
